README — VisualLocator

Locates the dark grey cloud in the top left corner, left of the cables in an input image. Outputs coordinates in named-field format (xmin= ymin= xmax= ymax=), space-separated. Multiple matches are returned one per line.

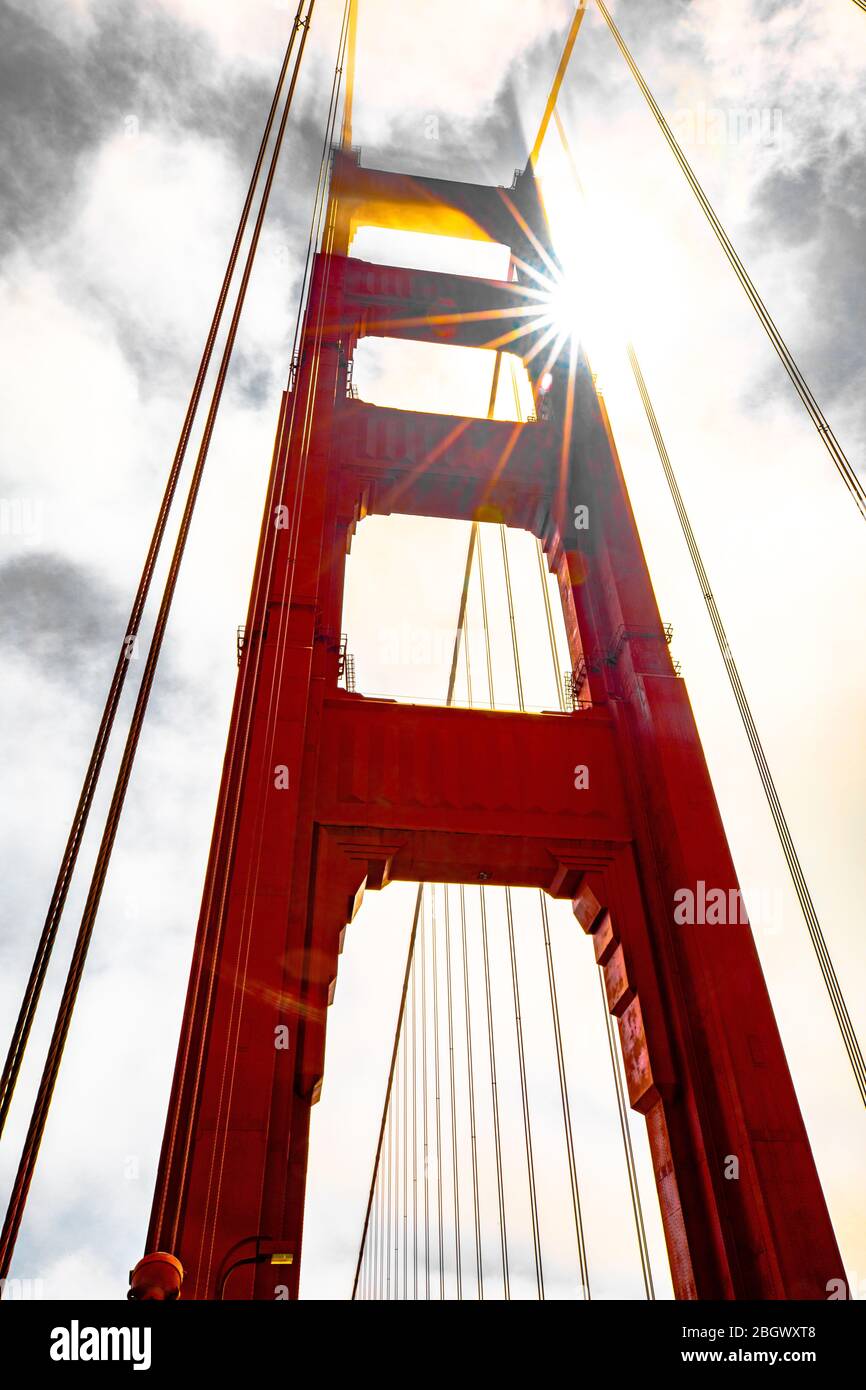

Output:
xmin=0 ymin=0 xmax=301 ymax=249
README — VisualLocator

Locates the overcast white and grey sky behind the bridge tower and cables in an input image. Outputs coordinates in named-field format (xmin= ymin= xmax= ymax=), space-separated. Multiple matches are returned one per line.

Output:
xmin=0 ymin=0 xmax=866 ymax=1298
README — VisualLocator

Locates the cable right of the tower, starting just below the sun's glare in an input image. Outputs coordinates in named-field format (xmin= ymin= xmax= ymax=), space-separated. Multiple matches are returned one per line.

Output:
xmin=628 ymin=343 xmax=866 ymax=1104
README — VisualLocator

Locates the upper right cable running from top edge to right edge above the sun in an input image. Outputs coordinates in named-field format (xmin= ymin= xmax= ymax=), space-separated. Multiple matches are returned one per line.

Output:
xmin=596 ymin=0 xmax=866 ymax=518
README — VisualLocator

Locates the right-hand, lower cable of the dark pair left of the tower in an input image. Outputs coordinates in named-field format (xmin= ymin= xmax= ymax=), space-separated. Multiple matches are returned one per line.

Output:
xmin=0 ymin=0 xmax=316 ymax=1279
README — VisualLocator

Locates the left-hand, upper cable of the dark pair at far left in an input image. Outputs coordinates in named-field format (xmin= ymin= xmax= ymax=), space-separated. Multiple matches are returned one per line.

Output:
xmin=0 ymin=0 xmax=306 ymax=1134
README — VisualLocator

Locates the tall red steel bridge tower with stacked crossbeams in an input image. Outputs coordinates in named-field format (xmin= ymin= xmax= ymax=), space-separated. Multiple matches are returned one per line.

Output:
xmin=147 ymin=156 xmax=842 ymax=1298
